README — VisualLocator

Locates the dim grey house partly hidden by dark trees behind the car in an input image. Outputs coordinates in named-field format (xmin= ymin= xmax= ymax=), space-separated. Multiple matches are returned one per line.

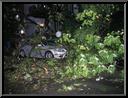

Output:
xmin=24 ymin=4 xmax=79 ymax=36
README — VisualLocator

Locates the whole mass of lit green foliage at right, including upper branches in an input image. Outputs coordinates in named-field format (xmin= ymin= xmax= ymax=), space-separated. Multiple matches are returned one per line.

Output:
xmin=55 ymin=5 xmax=124 ymax=78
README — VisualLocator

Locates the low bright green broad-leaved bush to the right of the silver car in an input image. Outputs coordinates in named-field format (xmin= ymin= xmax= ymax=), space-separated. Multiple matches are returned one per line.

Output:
xmin=57 ymin=30 xmax=124 ymax=78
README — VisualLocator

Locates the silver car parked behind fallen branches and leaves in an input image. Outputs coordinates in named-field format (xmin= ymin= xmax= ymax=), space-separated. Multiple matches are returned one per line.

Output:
xmin=20 ymin=42 xmax=67 ymax=59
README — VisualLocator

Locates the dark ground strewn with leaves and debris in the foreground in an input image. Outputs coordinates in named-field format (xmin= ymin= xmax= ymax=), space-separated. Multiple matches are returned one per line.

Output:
xmin=4 ymin=57 xmax=124 ymax=95
